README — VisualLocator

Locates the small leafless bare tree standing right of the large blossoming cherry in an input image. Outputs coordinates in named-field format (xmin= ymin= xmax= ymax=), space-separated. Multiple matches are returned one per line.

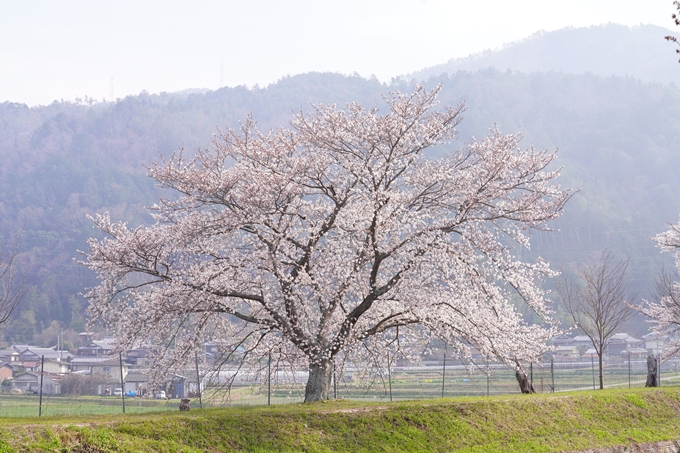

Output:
xmin=557 ymin=251 xmax=635 ymax=389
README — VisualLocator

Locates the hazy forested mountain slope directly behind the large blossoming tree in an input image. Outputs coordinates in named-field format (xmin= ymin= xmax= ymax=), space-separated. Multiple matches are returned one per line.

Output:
xmin=0 ymin=25 xmax=680 ymax=342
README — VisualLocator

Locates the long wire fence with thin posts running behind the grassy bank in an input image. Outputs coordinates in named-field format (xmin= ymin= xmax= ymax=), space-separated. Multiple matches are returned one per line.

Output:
xmin=0 ymin=359 xmax=680 ymax=417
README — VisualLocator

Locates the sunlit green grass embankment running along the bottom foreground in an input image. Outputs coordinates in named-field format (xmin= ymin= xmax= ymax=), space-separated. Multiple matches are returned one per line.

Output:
xmin=0 ymin=387 xmax=680 ymax=453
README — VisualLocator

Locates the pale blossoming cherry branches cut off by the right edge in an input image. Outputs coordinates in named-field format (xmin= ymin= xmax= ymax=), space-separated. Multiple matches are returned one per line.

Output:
xmin=638 ymin=222 xmax=680 ymax=358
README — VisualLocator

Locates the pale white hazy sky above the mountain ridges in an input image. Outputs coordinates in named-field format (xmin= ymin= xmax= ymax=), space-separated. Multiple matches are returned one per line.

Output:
xmin=0 ymin=0 xmax=680 ymax=105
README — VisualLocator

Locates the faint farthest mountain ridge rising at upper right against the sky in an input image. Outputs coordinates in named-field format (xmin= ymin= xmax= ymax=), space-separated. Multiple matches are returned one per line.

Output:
xmin=405 ymin=23 xmax=680 ymax=84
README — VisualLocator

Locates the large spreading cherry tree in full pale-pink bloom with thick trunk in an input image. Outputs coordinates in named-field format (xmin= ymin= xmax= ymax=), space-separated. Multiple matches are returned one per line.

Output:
xmin=84 ymin=87 xmax=570 ymax=401
